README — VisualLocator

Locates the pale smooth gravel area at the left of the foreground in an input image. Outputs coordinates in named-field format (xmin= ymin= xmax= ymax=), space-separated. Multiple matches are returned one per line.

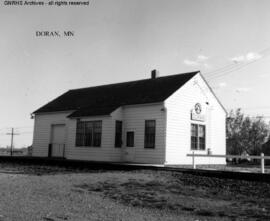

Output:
xmin=0 ymin=172 xmax=207 ymax=221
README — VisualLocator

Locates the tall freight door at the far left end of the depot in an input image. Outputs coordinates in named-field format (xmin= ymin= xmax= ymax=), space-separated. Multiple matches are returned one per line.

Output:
xmin=51 ymin=124 xmax=65 ymax=157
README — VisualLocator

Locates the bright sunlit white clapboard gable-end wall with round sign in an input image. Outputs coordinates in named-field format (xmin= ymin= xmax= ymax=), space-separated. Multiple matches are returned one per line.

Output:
xmin=165 ymin=74 xmax=226 ymax=164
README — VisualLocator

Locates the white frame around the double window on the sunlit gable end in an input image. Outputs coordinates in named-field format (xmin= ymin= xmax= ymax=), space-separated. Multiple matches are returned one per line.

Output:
xmin=190 ymin=122 xmax=206 ymax=151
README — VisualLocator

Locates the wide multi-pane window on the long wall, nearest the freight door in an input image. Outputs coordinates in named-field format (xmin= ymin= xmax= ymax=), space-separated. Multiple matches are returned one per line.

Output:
xmin=76 ymin=120 xmax=102 ymax=147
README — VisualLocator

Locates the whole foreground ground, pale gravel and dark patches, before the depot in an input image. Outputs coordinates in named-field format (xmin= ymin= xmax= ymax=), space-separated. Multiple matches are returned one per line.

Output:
xmin=0 ymin=163 xmax=270 ymax=221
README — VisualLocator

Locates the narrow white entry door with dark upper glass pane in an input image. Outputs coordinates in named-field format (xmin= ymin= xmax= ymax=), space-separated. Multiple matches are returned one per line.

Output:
xmin=123 ymin=130 xmax=135 ymax=162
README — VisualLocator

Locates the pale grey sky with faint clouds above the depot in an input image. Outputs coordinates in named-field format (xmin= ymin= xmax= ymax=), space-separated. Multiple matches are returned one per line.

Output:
xmin=0 ymin=0 xmax=270 ymax=148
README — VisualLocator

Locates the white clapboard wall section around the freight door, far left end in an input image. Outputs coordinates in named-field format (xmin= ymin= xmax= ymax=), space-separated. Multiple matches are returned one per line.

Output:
xmin=33 ymin=112 xmax=71 ymax=157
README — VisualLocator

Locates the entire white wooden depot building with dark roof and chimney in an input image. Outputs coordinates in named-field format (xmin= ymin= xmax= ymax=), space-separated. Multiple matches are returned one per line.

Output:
xmin=33 ymin=71 xmax=226 ymax=164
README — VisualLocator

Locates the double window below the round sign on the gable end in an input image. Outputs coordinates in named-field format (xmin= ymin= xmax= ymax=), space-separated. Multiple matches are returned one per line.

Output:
xmin=191 ymin=124 xmax=205 ymax=150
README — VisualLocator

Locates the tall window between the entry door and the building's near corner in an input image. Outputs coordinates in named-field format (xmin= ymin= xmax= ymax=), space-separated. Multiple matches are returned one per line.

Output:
xmin=144 ymin=120 xmax=156 ymax=148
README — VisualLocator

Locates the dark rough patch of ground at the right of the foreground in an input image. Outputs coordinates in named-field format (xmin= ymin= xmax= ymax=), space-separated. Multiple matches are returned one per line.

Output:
xmin=73 ymin=173 xmax=270 ymax=220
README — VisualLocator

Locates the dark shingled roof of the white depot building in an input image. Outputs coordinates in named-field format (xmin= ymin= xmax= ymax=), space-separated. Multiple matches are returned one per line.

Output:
xmin=34 ymin=71 xmax=199 ymax=117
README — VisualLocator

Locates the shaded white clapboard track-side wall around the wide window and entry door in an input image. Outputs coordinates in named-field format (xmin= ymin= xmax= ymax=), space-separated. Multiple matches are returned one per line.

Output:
xmin=66 ymin=104 xmax=165 ymax=164
